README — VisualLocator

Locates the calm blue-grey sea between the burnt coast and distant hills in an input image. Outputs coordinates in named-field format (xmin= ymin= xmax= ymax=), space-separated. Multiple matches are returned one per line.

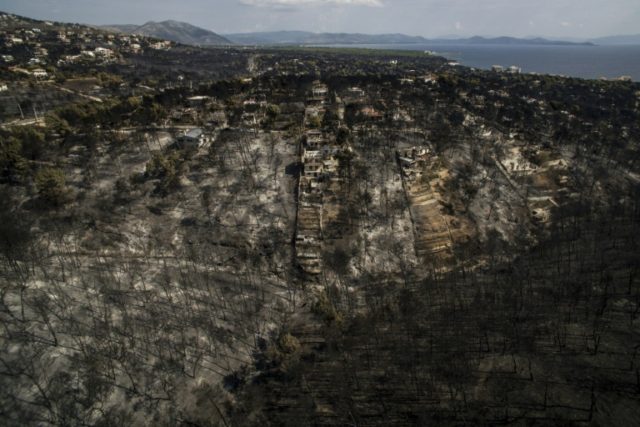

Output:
xmin=322 ymin=44 xmax=640 ymax=82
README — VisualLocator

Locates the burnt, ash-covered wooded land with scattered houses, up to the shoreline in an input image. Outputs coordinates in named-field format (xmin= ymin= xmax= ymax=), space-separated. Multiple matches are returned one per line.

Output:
xmin=0 ymin=14 xmax=640 ymax=427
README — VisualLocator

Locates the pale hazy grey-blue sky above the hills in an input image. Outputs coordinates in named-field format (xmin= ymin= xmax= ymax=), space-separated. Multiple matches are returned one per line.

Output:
xmin=0 ymin=0 xmax=640 ymax=38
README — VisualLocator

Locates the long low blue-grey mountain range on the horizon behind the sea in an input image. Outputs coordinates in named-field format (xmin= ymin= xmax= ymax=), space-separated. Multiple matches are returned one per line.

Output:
xmin=225 ymin=31 xmax=590 ymax=45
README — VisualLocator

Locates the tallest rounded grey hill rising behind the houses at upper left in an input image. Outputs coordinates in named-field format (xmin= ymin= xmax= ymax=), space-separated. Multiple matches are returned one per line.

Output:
xmin=101 ymin=21 xmax=233 ymax=46
